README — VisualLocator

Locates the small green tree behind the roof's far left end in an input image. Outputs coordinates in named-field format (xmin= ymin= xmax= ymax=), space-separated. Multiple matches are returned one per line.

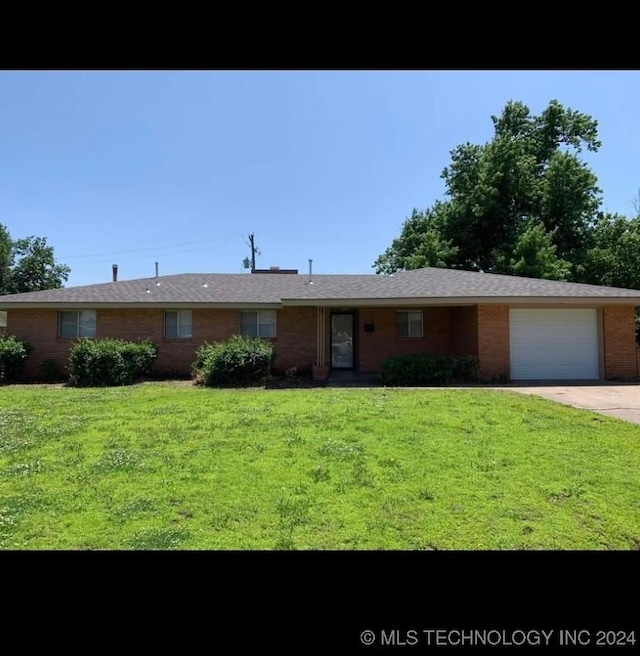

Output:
xmin=0 ymin=224 xmax=71 ymax=295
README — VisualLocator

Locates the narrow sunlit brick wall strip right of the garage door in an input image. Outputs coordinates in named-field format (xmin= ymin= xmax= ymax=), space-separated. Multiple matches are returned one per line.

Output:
xmin=602 ymin=305 xmax=638 ymax=378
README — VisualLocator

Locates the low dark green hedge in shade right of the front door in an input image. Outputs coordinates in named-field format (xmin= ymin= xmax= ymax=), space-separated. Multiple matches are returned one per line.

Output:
xmin=380 ymin=353 xmax=478 ymax=386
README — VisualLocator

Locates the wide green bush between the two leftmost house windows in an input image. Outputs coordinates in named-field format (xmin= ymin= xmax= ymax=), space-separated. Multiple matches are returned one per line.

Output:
xmin=69 ymin=339 xmax=157 ymax=387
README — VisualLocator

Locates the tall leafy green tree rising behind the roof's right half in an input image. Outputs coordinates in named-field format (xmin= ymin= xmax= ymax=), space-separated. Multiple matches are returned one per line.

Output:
xmin=374 ymin=100 xmax=601 ymax=280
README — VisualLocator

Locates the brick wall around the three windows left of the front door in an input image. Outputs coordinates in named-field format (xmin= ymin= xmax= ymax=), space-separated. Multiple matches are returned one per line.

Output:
xmin=7 ymin=308 xmax=316 ymax=378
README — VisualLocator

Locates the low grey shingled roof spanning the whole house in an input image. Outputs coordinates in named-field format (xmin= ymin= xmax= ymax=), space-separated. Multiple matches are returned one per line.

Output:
xmin=0 ymin=268 xmax=640 ymax=310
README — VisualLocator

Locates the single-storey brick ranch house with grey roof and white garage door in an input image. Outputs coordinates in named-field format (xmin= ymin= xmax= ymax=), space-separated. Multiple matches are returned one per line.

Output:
xmin=0 ymin=268 xmax=640 ymax=381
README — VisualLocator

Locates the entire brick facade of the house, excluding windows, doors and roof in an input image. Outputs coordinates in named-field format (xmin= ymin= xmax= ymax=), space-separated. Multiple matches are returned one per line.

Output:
xmin=7 ymin=305 xmax=640 ymax=381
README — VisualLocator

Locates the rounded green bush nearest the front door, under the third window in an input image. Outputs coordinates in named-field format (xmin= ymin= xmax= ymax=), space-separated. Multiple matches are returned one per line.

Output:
xmin=193 ymin=335 xmax=276 ymax=387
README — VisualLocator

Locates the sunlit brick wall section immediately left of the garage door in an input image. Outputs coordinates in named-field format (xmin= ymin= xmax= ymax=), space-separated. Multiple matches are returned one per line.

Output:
xmin=478 ymin=305 xmax=511 ymax=381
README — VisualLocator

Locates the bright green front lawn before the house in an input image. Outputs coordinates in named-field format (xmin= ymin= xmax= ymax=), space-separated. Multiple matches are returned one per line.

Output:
xmin=0 ymin=383 xmax=640 ymax=550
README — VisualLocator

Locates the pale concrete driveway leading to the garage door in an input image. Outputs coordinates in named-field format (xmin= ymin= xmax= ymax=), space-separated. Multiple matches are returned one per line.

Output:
xmin=504 ymin=383 xmax=640 ymax=424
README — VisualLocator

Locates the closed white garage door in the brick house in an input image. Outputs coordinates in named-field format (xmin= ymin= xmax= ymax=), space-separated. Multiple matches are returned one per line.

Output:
xmin=510 ymin=310 xmax=599 ymax=380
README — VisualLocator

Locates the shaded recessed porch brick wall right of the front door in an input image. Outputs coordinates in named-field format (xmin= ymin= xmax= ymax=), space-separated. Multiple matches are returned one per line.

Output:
xmin=356 ymin=307 xmax=452 ymax=372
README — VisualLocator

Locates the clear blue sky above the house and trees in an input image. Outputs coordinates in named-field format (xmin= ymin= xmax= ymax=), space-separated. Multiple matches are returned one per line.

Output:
xmin=0 ymin=70 xmax=640 ymax=286
